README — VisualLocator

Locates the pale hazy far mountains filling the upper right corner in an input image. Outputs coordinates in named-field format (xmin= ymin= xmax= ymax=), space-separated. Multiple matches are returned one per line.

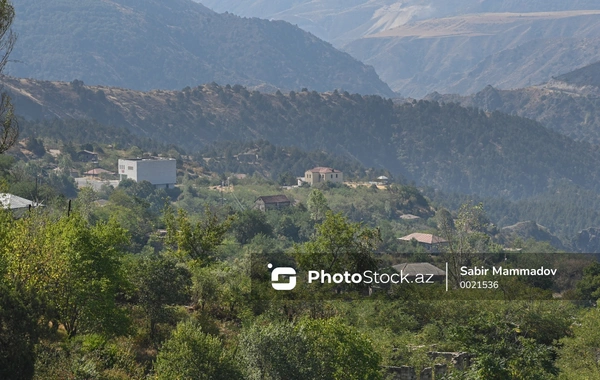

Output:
xmin=203 ymin=0 xmax=600 ymax=98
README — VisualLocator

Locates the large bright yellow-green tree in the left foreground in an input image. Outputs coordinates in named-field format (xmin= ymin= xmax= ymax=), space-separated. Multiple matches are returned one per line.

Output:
xmin=0 ymin=213 xmax=127 ymax=337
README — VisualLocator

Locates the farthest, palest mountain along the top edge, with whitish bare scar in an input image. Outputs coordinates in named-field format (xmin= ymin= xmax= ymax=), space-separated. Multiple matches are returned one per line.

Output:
xmin=198 ymin=0 xmax=600 ymax=47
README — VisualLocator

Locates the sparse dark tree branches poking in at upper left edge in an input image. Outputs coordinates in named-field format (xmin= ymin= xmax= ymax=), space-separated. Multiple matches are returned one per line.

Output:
xmin=0 ymin=0 xmax=19 ymax=154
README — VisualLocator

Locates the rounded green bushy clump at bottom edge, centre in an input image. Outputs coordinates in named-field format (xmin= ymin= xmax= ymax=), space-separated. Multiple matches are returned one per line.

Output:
xmin=240 ymin=319 xmax=381 ymax=380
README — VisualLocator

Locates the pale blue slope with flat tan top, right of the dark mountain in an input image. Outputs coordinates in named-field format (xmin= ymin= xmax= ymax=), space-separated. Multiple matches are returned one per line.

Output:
xmin=344 ymin=10 xmax=600 ymax=97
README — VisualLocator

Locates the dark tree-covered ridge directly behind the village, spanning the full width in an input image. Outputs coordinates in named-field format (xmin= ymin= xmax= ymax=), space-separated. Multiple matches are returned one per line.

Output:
xmin=3 ymin=78 xmax=600 ymax=199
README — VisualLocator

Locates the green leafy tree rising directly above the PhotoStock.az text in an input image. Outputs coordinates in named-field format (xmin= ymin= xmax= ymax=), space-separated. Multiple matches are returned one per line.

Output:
xmin=295 ymin=211 xmax=381 ymax=273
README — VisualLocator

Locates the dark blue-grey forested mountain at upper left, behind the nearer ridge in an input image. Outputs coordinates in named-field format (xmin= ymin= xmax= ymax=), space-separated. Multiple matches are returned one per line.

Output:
xmin=7 ymin=0 xmax=393 ymax=96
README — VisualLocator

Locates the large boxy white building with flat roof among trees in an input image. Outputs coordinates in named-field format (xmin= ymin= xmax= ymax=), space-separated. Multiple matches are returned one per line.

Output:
xmin=119 ymin=158 xmax=177 ymax=189
